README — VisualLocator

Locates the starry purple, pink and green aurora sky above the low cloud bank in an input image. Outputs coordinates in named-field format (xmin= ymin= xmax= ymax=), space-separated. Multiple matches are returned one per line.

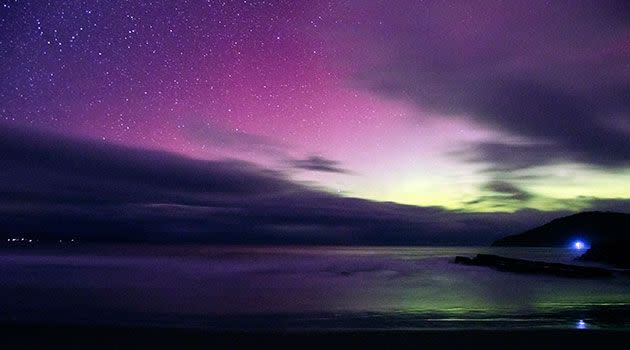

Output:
xmin=0 ymin=0 xmax=630 ymax=215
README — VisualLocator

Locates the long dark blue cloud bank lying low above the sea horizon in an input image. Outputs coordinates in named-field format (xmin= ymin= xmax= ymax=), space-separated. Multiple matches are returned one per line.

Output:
xmin=0 ymin=125 xmax=628 ymax=245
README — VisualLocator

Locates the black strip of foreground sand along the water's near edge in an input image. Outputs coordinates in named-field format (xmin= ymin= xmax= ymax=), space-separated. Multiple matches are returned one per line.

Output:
xmin=0 ymin=324 xmax=630 ymax=350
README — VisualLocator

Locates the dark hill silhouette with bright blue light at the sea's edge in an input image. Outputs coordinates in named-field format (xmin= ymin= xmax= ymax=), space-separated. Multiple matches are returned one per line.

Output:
xmin=492 ymin=211 xmax=630 ymax=247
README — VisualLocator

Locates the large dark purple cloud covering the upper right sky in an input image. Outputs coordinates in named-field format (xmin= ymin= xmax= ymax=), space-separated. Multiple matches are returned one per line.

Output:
xmin=329 ymin=1 xmax=630 ymax=169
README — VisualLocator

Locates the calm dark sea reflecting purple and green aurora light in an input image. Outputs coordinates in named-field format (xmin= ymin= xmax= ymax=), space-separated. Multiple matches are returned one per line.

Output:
xmin=0 ymin=245 xmax=630 ymax=330
